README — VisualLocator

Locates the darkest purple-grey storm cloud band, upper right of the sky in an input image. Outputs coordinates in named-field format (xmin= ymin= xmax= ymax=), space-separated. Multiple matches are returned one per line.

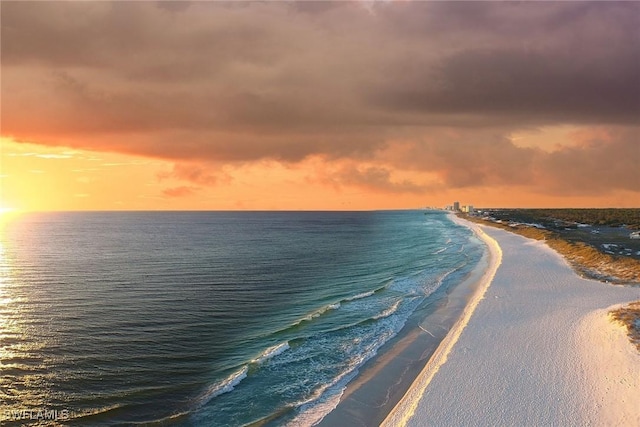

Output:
xmin=377 ymin=44 xmax=640 ymax=124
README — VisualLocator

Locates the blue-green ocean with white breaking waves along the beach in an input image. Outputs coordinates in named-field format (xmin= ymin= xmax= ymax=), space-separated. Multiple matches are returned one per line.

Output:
xmin=0 ymin=211 xmax=484 ymax=426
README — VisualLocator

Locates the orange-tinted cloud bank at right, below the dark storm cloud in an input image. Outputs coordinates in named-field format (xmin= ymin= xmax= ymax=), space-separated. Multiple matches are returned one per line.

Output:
xmin=370 ymin=126 xmax=640 ymax=195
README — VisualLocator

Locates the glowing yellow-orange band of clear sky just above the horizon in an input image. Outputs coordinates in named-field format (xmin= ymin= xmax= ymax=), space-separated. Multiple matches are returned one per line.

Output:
xmin=0 ymin=135 xmax=640 ymax=211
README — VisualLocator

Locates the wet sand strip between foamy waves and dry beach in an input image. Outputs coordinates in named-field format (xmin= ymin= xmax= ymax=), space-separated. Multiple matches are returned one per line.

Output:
xmin=314 ymin=215 xmax=496 ymax=427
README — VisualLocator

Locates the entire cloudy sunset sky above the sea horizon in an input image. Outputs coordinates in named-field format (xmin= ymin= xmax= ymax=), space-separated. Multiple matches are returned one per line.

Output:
xmin=0 ymin=0 xmax=640 ymax=211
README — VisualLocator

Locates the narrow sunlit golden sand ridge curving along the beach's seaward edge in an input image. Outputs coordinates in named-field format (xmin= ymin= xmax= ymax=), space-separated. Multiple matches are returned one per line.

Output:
xmin=380 ymin=216 xmax=502 ymax=427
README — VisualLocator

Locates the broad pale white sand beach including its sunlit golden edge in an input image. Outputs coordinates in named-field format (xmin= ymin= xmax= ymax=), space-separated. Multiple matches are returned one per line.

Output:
xmin=383 ymin=220 xmax=640 ymax=427
